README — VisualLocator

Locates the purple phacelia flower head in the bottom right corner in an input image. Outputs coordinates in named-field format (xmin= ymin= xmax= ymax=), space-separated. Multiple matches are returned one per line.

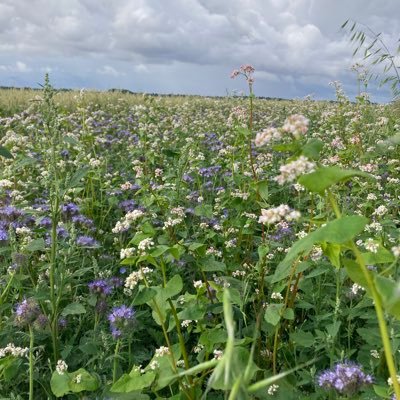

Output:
xmin=318 ymin=362 xmax=373 ymax=396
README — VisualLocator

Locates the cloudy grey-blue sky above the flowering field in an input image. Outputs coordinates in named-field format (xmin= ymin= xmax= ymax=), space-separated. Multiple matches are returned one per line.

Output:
xmin=0 ymin=0 xmax=400 ymax=102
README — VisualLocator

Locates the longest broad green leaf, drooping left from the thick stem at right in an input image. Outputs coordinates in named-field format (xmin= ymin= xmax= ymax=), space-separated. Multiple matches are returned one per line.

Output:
xmin=272 ymin=215 xmax=368 ymax=283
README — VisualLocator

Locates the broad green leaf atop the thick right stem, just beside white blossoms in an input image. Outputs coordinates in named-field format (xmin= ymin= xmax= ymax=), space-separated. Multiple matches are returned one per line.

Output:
xmin=298 ymin=167 xmax=371 ymax=194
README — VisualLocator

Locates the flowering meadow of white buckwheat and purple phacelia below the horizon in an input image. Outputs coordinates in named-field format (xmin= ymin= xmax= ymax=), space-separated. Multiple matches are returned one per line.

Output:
xmin=0 ymin=65 xmax=400 ymax=400
